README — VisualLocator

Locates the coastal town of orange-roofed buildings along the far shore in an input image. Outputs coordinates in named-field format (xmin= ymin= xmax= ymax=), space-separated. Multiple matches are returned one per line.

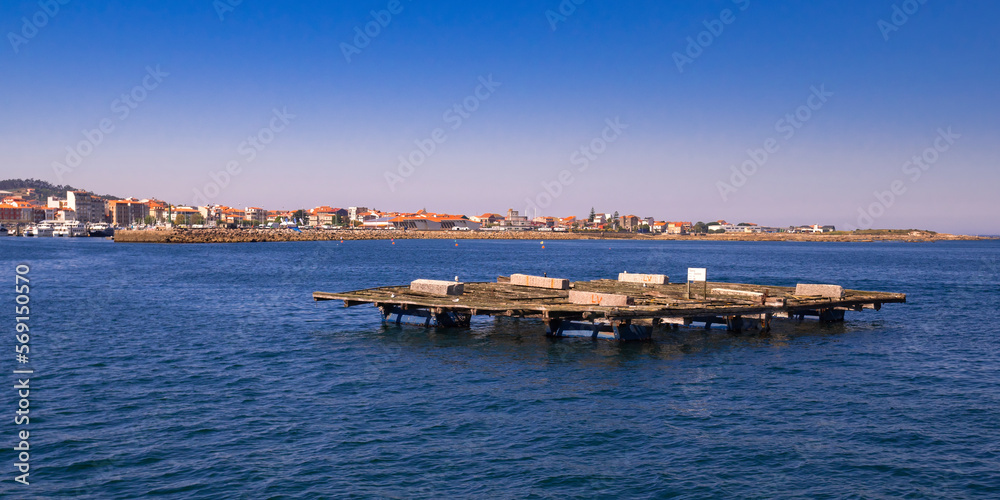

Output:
xmin=0 ymin=183 xmax=836 ymax=236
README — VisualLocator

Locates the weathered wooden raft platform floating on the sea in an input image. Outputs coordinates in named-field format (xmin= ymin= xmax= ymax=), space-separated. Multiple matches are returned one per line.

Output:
xmin=313 ymin=276 xmax=906 ymax=340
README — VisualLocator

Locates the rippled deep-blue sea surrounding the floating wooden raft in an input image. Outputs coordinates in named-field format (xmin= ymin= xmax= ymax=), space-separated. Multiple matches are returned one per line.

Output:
xmin=0 ymin=237 xmax=1000 ymax=499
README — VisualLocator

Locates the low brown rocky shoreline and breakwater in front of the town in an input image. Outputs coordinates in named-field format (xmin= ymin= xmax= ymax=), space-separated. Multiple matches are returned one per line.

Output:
xmin=115 ymin=229 xmax=995 ymax=243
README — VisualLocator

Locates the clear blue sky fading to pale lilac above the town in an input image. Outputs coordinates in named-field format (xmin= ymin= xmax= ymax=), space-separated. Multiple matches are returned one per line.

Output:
xmin=0 ymin=0 xmax=1000 ymax=234
